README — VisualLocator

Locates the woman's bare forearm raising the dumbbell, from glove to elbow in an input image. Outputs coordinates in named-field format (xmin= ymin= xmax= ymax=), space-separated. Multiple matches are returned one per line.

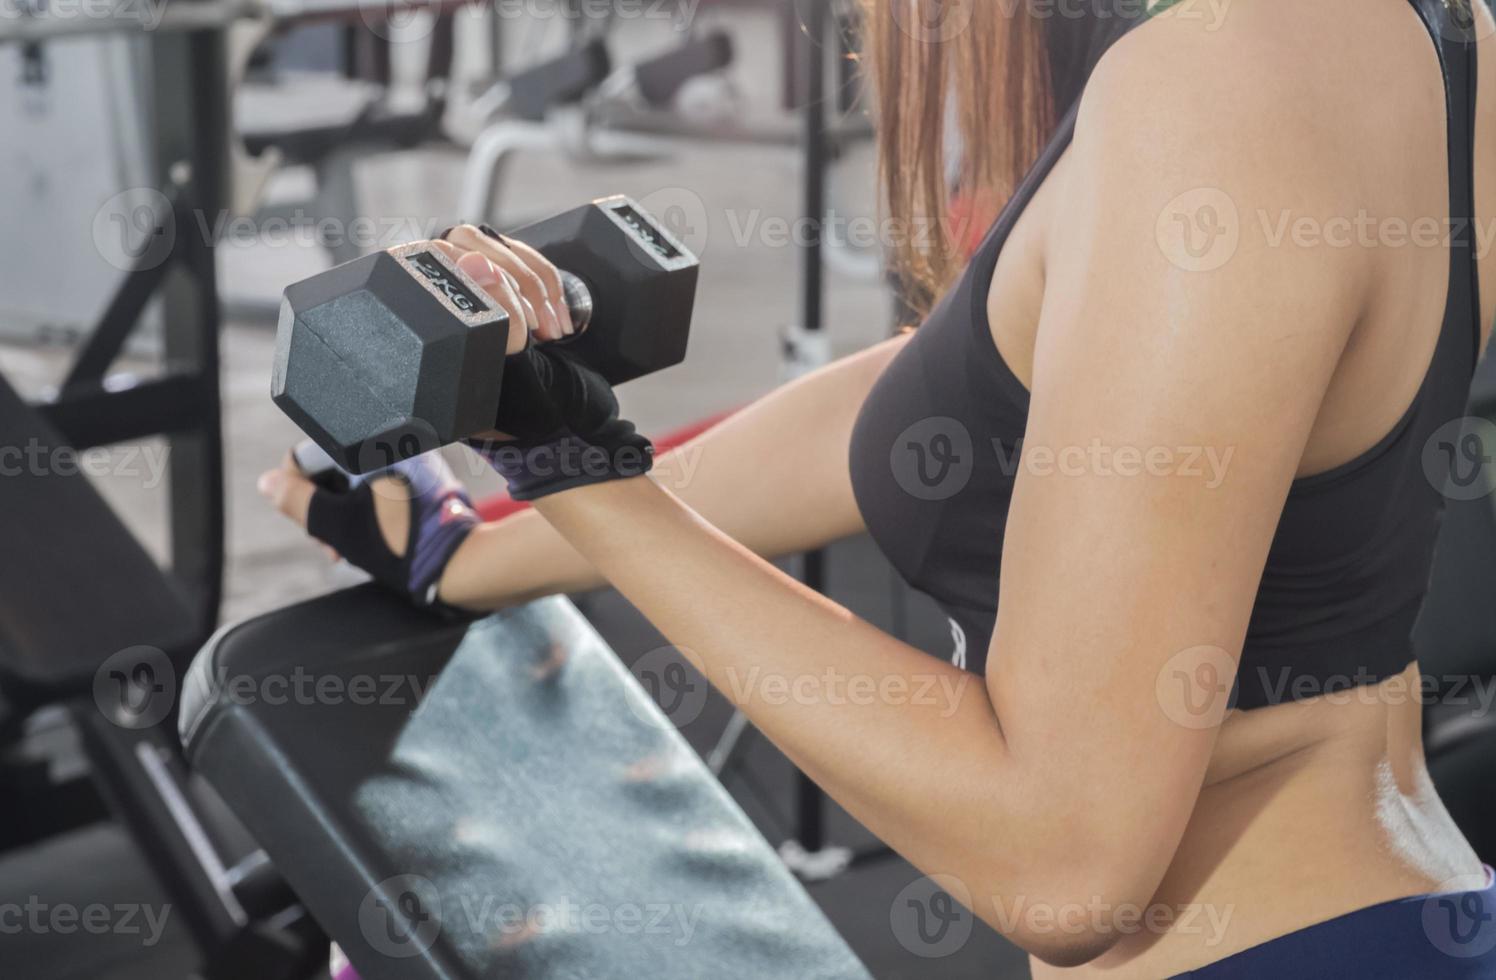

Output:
xmin=536 ymin=479 xmax=1074 ymax=914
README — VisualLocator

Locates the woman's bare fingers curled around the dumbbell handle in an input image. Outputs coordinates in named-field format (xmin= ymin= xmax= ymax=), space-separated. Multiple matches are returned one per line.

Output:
xmin=431 ymin=224 xmax=576 ymax=353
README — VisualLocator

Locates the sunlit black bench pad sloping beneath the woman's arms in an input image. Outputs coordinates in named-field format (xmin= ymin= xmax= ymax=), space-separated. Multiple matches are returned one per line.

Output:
xmin=181 ymin=587 xmax=868 ymax=980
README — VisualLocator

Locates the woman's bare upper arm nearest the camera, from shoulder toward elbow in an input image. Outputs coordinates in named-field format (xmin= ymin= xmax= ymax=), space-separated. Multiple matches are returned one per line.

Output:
xmin=987 ymin=24 xmax=1361 ymax=887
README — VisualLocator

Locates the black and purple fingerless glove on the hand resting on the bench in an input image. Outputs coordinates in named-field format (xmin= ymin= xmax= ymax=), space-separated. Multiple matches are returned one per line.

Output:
xmin=307 ymin=452 xmax=482 ymax=616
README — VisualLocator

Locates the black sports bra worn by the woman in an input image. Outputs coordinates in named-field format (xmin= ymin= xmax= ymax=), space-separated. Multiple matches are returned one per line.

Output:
xmin=851 ymin=0 xmax=1481 ymax=708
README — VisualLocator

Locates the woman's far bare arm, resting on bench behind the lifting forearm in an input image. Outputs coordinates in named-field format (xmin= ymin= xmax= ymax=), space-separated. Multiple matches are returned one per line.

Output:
xmin=441 ymin=338 xmax=905 ymax=609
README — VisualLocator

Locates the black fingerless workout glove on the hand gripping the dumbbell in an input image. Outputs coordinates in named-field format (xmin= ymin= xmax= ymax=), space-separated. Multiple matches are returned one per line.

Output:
xmin=468 ymin=344 xmax=654 ymax=500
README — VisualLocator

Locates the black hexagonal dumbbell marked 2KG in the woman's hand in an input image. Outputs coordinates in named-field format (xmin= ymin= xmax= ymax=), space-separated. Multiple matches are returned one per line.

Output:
xmin=271 ymin=196 xmax=699 ymax=473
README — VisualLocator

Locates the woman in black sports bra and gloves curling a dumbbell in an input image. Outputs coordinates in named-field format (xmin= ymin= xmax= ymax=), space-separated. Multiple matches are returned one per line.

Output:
xmin=263 ymin=0 xmax=1496 ymax=977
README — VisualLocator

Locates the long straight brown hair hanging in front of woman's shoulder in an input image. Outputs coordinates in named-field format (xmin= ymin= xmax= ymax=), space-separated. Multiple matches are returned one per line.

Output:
xmin=863 ymin=0 xmax=1055 ymax=313
